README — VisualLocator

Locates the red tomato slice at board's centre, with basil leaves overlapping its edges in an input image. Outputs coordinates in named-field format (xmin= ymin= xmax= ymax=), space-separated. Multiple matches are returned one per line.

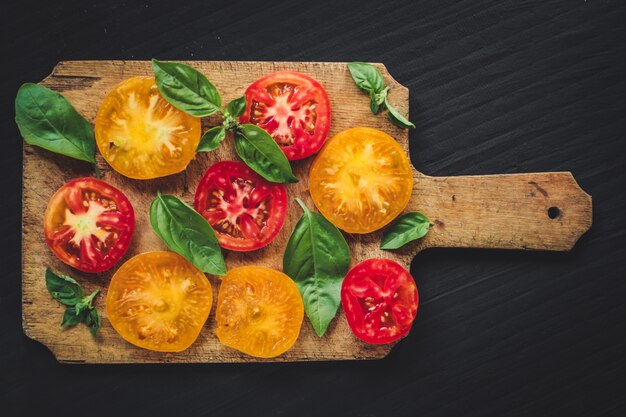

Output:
xmin=193 ymin=161 xmax=287 ymax=252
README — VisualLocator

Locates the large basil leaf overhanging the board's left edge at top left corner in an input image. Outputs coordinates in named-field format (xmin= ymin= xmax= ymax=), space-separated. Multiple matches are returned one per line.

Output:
xmin=15 ymin=83 xmax=96 ymax=165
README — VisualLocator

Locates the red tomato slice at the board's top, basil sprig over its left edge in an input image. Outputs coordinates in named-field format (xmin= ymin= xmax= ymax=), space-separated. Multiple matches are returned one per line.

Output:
xmin=239 ymin=71 xmax=330 ymax=161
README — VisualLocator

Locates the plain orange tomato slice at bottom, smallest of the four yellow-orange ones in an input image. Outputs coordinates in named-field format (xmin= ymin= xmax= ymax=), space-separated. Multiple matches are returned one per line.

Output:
xmin=215 ymin=266 xmax=304 ymax=358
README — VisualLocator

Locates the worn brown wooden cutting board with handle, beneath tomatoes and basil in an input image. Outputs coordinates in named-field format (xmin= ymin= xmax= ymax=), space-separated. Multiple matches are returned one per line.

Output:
xmin=22 ymin=61 xmax=592 ymax=363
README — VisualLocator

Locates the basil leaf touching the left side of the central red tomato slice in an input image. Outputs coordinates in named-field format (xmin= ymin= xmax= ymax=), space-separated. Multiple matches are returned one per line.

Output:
xmin=150 ymin=193 xmax=226 ymax=276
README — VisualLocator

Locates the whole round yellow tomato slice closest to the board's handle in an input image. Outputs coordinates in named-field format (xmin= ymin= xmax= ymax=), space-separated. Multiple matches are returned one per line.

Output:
xmin=309 ymin=127 xmax=413 ymax=233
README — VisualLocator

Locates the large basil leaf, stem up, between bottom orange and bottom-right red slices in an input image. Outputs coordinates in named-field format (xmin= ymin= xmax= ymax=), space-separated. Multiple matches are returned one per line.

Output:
xmin=283 ymin=199 xmax=350 ymax=337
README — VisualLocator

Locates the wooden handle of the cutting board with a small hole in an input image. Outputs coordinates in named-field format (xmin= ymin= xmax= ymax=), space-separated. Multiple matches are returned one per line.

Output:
xmin=407 ymin=172 xmax=592 ymax=251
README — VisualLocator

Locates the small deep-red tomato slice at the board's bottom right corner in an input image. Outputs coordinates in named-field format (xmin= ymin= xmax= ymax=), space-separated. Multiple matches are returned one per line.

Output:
xmin=341 ymin=259 xmax=419 ymax=344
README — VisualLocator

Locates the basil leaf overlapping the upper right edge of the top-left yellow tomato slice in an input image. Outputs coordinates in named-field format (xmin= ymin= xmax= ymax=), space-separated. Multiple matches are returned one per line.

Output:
xmin=152 ymin=59 xmax=222 ymax=117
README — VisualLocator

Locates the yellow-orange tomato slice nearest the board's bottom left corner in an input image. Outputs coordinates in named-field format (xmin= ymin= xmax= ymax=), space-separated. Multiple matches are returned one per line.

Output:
xmin=106 ymin=252 xmax=213 ymax=352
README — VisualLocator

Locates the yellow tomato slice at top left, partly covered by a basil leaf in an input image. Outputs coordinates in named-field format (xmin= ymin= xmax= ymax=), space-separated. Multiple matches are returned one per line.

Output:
xmin=95 ymin=77 xmax=200 ymax=179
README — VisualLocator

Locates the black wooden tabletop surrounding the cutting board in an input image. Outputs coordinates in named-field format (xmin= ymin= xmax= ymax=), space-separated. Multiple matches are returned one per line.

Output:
xmin=0 ymin=0 xmax=626 ymax=417
